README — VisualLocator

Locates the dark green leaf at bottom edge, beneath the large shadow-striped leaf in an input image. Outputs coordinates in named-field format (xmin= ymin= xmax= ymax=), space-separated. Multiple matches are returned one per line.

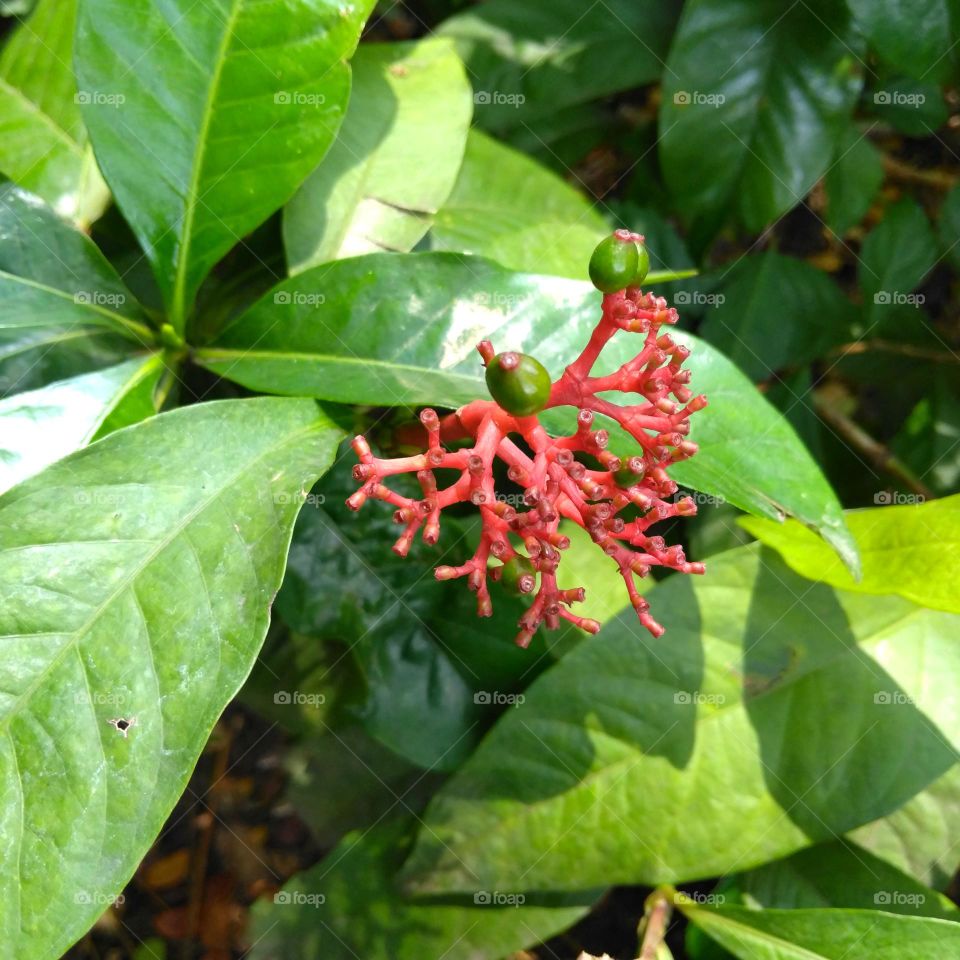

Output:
xmin=250 ymin=819 xmax=593 ymax=960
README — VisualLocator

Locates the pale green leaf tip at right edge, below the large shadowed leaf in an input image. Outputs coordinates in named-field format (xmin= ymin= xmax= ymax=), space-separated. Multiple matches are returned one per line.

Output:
xmin=850 ymin=765 xmax=960 ymax=890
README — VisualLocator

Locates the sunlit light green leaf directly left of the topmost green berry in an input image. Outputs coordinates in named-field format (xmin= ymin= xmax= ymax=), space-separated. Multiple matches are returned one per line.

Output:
xmin=430 ymin=130 xmax=610 ymax=280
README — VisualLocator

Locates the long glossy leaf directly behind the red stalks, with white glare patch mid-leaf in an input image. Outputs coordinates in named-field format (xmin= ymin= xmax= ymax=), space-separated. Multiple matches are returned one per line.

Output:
xmin=196 ymin=253 xmax=855 ymax=566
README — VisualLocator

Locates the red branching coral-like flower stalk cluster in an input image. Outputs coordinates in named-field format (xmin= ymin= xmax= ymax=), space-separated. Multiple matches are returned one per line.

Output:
xmin=347 ymin=268 xmax=707 ymax=647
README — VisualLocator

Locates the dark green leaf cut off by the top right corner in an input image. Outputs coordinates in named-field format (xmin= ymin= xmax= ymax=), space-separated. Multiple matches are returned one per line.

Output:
xmin=850 ymin=0 xmax=960 ymax=81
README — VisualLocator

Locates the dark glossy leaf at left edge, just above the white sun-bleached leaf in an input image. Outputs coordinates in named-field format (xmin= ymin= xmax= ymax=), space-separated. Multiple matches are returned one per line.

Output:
xmin=0 ymin=183 xmax=154 ymax=393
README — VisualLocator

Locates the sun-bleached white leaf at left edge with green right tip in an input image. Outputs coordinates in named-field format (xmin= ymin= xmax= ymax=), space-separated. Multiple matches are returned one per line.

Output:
xmin=0 ymin=354 xmax=163 ymax=493
